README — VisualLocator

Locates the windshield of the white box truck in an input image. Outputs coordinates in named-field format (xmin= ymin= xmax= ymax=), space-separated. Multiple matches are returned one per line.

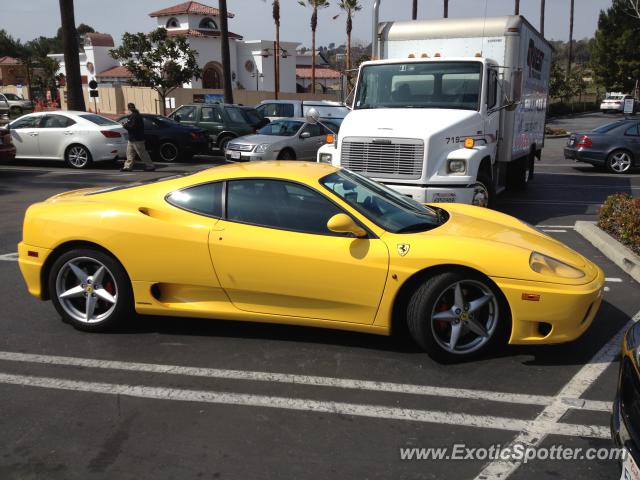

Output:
xmin=355 ymin=61 xmax=482 ymax=110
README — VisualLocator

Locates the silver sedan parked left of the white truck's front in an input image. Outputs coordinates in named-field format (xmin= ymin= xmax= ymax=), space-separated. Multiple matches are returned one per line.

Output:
xmin=225 ymin=118 xmax=338 ymax=162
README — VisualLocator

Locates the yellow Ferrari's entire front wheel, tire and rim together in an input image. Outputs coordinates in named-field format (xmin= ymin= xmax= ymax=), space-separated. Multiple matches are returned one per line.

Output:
xmin=407 ymin=271 xmax=511 ymax=362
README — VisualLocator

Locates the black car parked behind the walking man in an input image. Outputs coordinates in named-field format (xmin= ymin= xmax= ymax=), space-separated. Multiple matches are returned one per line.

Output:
xmin=118 ymin=114 xmax=209 ymax=162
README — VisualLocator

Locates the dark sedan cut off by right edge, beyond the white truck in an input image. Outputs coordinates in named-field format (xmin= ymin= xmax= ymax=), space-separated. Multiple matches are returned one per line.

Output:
xmin=564 ymin=119 xmax=640 ymax=173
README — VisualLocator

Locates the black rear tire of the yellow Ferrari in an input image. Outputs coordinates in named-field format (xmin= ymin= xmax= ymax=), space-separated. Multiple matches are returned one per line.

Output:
xmin=48 ymin=248 xmax=134 ymax=332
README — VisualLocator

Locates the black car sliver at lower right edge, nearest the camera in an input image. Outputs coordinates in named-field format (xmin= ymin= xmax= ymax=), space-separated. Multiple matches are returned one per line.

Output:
xmin=611 ymin=323 xmax=640 ymax=479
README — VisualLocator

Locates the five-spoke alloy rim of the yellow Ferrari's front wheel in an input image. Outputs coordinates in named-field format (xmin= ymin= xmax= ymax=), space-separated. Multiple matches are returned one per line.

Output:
xmin=430 ymin=280 xmax=499 ymax=355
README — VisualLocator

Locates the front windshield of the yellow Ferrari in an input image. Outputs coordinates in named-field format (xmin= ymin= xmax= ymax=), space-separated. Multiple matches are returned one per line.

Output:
xmin=320 ymin=169 xmax=446 ymax=233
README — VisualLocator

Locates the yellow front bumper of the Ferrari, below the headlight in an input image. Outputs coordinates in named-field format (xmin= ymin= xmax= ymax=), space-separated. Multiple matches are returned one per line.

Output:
xmin=493 ymin=267 xmax=604 ymax=345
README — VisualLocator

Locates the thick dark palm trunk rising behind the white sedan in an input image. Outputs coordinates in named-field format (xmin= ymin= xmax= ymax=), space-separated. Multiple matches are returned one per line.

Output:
xmin=59 ymin=0 xmax=86 ymax=111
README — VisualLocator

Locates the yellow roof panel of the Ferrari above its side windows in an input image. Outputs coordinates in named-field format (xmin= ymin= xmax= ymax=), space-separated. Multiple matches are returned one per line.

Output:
xmin=185 ymin=160 xmax=339 ymax=185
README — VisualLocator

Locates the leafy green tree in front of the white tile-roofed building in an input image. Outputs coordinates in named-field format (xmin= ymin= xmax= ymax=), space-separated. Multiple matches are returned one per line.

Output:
xmin=109 ymin=28 xmax=202 ymax=114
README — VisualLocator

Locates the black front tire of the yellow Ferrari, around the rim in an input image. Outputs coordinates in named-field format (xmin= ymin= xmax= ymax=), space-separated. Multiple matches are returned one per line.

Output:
xmin=407 ymin=271 xmax=511 ymax=363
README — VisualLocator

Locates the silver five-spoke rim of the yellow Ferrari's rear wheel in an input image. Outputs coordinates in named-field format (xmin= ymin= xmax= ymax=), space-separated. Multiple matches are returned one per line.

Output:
xmin=56 ymin=257 xmax=118 ymax=323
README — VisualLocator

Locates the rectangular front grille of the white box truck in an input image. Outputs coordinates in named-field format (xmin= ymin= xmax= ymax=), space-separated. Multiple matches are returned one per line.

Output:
xmin=341 ymin=137 xmax=424 ymax=179
